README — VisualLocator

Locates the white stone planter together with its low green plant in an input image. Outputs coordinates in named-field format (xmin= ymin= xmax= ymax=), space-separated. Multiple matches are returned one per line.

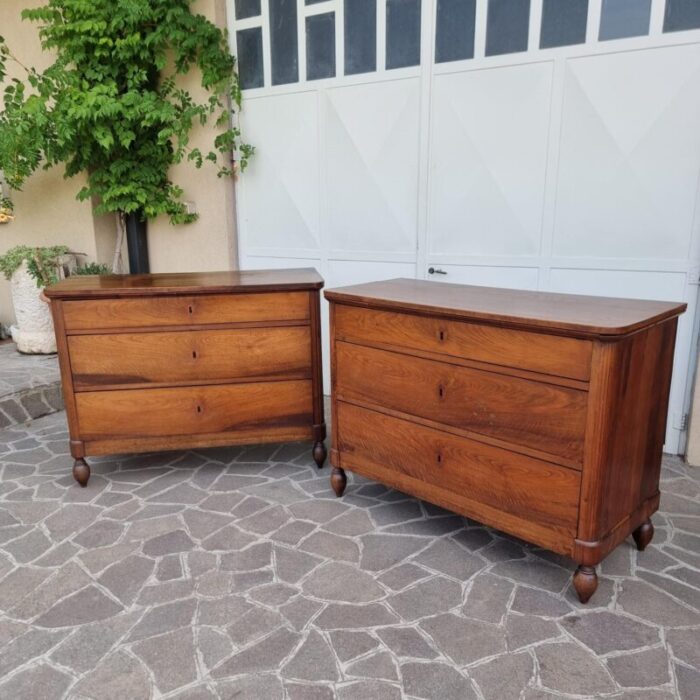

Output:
xmin=0 ymin=245 xmax=74 ymax=355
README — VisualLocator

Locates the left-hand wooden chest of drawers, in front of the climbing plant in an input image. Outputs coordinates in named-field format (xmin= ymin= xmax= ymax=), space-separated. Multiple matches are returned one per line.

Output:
xmin=46 ymin=269 xmax=326 ymax=486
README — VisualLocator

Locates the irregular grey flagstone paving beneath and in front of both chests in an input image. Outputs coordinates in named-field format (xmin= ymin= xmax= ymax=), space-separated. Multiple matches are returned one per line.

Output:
xmin=0 ymin=413 xmax=700 ymax=700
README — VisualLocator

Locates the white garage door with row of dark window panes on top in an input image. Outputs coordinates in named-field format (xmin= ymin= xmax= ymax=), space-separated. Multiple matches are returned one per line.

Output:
xmin=229 ymin=0 xmax=700 ymax=452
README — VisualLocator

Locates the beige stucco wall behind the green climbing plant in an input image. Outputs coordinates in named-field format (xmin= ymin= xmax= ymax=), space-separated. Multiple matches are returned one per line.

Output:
xmin=0 ymin=0 xmax=237 ymax=324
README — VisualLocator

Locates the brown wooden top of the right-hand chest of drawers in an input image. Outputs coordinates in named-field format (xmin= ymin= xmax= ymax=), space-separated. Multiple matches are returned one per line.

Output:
xmin=325 ymin=279 xmax=687 ymax=336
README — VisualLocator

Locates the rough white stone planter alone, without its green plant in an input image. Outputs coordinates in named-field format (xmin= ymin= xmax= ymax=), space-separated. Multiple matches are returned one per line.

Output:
xmin=10 ymin=262 xmax=56 ymax=355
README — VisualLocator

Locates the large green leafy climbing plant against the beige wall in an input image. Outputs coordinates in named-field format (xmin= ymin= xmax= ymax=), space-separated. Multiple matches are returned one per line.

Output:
xmin=0 ymin=0 xmax=254 ymax=224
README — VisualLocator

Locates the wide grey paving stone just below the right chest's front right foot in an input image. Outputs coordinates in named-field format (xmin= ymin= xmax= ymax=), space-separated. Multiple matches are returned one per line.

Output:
xmin=562 ymin=611 xmax=659 ymax=655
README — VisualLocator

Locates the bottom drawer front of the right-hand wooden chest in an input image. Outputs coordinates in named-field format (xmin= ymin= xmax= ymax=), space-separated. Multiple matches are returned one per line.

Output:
xmin=337 ymin=401 xmax=580 ymax=544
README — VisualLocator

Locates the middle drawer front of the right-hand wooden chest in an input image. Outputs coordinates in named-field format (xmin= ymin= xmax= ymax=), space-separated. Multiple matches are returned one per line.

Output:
xmin=336 ymin=342 xmax=588 ymax=468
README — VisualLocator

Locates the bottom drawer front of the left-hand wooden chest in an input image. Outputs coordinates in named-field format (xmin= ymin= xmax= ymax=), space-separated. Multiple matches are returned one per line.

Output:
xmin=75 ymin=381 xmax=313 ymax=440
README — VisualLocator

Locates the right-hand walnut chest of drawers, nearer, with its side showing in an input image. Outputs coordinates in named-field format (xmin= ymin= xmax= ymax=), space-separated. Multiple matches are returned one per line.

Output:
xmin=325 ymin=279 xmax=685 ymax=602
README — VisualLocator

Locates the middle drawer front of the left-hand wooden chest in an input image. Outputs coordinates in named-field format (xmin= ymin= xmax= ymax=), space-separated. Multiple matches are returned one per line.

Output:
xmin=68 ymin=326 xmax=311 ymax=390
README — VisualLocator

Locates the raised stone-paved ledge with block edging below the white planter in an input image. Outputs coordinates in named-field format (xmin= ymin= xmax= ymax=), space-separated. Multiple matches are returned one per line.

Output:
xmin=0 ymin=342 xmax=63 ymax=429
